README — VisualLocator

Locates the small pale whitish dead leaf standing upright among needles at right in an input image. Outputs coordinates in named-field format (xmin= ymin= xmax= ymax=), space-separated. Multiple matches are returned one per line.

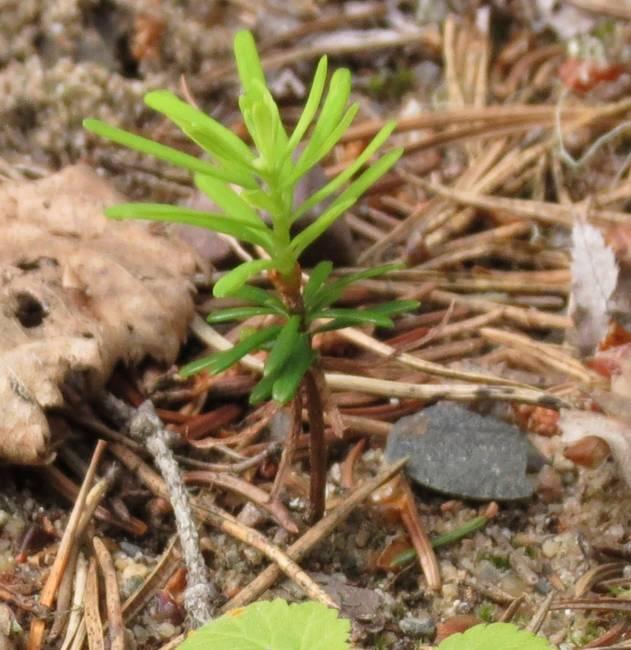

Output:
xmin=570 ymin=218 xmax=618 ymax=354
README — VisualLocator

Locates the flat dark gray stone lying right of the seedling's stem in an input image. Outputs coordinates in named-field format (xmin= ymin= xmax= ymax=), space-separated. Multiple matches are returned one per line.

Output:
xmin=386 ymin=402 xmax=533 ymax=501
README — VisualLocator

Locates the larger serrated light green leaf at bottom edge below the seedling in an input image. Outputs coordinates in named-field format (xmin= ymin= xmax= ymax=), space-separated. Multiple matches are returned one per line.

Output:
xmin=178 ymin=599 xmax=351 ymax=650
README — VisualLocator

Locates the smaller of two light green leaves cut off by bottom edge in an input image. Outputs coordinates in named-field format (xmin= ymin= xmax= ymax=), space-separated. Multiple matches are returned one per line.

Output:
xmin=438 ymin=623 xmax=554 ymax=650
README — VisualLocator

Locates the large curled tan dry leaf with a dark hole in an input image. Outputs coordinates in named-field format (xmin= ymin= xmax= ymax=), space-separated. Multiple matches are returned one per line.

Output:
xmin=0 ymin=165 xmax=196 ymax=464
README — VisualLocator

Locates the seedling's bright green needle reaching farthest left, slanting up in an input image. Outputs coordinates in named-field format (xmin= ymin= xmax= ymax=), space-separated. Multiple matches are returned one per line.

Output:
xmin=83 ymin=118 xmax=230 ymax=180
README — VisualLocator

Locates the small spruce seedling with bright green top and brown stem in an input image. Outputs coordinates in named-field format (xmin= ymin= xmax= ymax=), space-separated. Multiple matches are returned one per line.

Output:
xmin=84 ymin=31 xmax=418 ymax=520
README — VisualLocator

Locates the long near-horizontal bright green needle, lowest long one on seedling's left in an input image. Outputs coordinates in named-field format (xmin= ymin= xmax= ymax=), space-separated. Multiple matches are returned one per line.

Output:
xmin=105 ymin=203 xmax=274 ymax=248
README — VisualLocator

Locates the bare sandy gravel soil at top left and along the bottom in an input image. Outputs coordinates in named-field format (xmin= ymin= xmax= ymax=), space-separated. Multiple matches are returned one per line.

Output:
xmin=0 ymin=0 xmax=631 ymax=650
